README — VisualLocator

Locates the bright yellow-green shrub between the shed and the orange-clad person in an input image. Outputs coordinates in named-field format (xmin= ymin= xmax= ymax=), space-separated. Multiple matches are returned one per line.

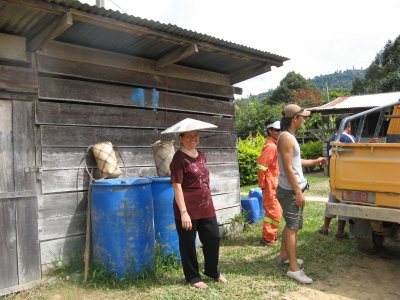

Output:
xmin=237 ymin=132 xmax=265 ymax=185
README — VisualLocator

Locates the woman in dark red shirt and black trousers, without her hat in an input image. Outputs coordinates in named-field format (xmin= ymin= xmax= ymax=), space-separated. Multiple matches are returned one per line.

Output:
xmin=170 ymin=130 xmax=227 ymax=288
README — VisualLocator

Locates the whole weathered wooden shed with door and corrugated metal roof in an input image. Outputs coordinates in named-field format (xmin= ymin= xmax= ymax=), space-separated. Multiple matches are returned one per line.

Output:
xmin=0 ymin=0 xmax=287 ymax=295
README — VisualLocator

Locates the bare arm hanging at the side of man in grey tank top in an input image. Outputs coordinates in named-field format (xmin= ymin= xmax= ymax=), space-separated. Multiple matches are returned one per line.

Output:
xmin=278 ymin=135 xmax=305 ymax=207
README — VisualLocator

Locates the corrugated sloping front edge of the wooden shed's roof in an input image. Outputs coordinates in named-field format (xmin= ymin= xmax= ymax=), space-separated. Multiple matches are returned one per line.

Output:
xmin=41 ymin=0 xmax=289 ymax=62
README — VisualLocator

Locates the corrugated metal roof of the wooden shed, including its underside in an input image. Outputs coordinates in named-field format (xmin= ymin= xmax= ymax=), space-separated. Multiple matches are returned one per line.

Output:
xmin=0 ymin=0 xmax=288 ymax=84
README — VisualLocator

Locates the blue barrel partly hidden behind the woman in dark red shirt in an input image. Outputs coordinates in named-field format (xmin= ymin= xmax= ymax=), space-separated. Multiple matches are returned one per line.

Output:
xmin=149 ymin=177 xmax=181 ymax=259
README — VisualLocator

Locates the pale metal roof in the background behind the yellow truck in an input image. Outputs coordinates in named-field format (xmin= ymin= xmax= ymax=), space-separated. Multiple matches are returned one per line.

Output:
xmin=310 ymin=92 xmax=400 ymax=111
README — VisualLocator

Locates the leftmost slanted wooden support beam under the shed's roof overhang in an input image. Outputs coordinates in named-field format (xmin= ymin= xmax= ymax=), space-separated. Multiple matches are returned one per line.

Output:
xmin=28 ymin=12 xmax=73 ymax=52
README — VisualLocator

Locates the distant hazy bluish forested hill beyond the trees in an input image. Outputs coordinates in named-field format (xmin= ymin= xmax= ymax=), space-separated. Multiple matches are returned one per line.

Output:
xmin=308 ymin=69 xmax=365 ymax=91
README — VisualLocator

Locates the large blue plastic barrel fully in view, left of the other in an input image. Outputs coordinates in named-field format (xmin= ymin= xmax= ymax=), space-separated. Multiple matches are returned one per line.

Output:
xmin=92 ymin=178 xmax=155 ymax=278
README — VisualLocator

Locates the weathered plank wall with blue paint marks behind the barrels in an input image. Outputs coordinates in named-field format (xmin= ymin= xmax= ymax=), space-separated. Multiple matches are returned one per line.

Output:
xmin=35 ymin=42 xmax=240 ymax=270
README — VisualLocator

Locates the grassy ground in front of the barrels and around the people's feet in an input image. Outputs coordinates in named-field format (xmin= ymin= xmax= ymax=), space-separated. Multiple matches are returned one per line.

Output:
xmin=10 ymin=202 xmax=362 ymax=300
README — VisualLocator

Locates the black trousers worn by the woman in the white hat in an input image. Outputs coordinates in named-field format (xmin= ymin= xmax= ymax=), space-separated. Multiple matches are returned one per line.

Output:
xmin=175 ymin=217 xmax=221 ymax=284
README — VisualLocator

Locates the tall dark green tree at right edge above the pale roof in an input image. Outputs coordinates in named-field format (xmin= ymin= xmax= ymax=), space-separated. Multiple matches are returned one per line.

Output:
xmin=352 ymin=35 xmax=400 ymax=95
